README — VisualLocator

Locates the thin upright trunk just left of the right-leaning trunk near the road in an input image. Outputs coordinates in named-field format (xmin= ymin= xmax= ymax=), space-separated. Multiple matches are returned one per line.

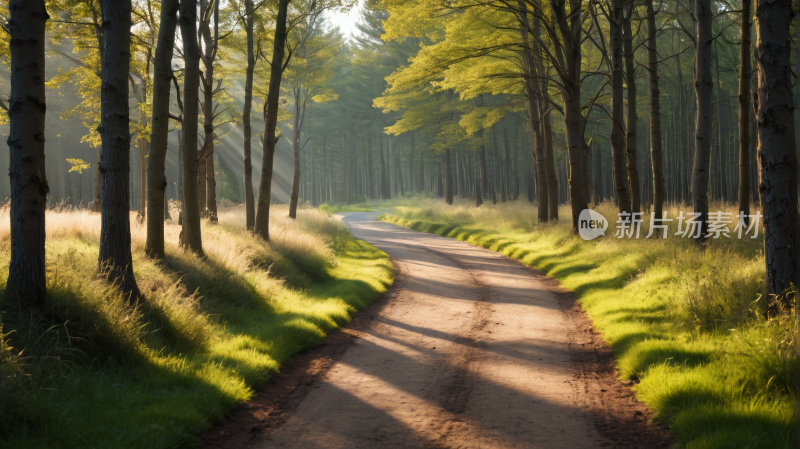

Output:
xmin=242 ymin=0 xmax=256 ymax=231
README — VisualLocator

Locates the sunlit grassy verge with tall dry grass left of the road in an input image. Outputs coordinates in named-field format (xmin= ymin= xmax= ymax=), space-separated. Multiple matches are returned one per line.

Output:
xmin=0 ymin=206 xmax=392 ymax=449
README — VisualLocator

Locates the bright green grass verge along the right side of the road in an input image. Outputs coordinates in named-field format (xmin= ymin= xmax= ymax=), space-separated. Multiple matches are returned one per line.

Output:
xmin=382 ymin=200 xmax=797 ymax=448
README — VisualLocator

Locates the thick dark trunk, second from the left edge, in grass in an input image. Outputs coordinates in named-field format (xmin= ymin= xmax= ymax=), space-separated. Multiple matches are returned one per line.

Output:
xmin=97 ymin=0 xmax=139 ymax=301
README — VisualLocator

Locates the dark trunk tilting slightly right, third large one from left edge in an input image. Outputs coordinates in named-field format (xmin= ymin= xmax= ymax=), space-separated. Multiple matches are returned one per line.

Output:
xmin=146 ymin=0 xmax=180 ymax=259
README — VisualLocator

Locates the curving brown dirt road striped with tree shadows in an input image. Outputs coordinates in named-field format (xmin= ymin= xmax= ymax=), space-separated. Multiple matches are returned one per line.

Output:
xmin=204 ymin=213 xmax=671 ymax=448
